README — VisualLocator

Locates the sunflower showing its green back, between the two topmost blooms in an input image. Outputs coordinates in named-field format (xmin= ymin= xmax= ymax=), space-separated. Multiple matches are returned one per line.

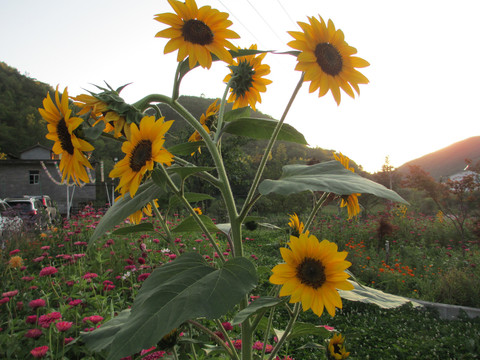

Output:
xmin=223 ymin=45 xmax=272 ymax=110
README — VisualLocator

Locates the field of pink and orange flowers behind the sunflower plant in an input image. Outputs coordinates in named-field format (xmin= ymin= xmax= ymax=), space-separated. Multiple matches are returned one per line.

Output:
xmin=0 ymin=204 xmax=480 ymax=360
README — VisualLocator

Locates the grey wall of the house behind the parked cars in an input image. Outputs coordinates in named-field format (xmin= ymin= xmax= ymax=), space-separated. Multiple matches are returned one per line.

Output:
xmin=0 ymin=160 xmax=96 ymax=214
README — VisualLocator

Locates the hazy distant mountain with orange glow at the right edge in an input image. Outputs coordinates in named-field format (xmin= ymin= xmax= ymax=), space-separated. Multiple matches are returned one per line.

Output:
xmin=397 ymin=136 xmax=480 ymax=180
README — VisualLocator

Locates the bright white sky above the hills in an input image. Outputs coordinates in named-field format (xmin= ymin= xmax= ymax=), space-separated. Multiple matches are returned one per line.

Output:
xmin=0 ymin=0 xmax=480 ymax=172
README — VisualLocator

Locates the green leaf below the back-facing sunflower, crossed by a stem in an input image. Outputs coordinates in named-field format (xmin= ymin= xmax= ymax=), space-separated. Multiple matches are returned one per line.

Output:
xmin=222 ymin=118 xmax=307 ymax=145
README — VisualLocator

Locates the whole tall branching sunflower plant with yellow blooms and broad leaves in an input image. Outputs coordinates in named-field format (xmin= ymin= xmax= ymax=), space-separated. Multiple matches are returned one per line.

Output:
xmin=40 ymin=0 xmax=410 ymax=360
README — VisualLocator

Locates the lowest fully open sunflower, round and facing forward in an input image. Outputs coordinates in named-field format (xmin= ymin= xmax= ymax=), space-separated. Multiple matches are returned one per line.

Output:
xmin=270 ymin=234 xmax=353 ymax=316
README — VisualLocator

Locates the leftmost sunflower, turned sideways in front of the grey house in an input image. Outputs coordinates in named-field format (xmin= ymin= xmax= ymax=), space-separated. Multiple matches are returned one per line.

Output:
xmin=38 ymin=86 xmax=94 ymax=184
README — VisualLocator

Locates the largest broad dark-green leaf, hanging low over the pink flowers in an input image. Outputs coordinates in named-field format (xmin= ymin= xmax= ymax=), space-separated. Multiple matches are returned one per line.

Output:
xmin=84 ymin=253 xmax=258 ymax=360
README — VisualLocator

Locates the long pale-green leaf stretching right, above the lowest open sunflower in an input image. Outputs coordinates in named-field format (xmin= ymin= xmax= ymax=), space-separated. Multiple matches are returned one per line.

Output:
xmin=258 ymin=160 xmax=408 ymax=204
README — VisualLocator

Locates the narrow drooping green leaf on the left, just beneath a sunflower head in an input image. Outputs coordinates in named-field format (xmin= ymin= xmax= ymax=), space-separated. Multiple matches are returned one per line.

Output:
xmin=89 ymin=180 xmax=165 ymax=245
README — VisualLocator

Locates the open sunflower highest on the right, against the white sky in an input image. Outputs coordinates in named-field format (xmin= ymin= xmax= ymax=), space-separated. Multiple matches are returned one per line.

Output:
xmin=288 ymin=16 xmax=370 ymax=105
